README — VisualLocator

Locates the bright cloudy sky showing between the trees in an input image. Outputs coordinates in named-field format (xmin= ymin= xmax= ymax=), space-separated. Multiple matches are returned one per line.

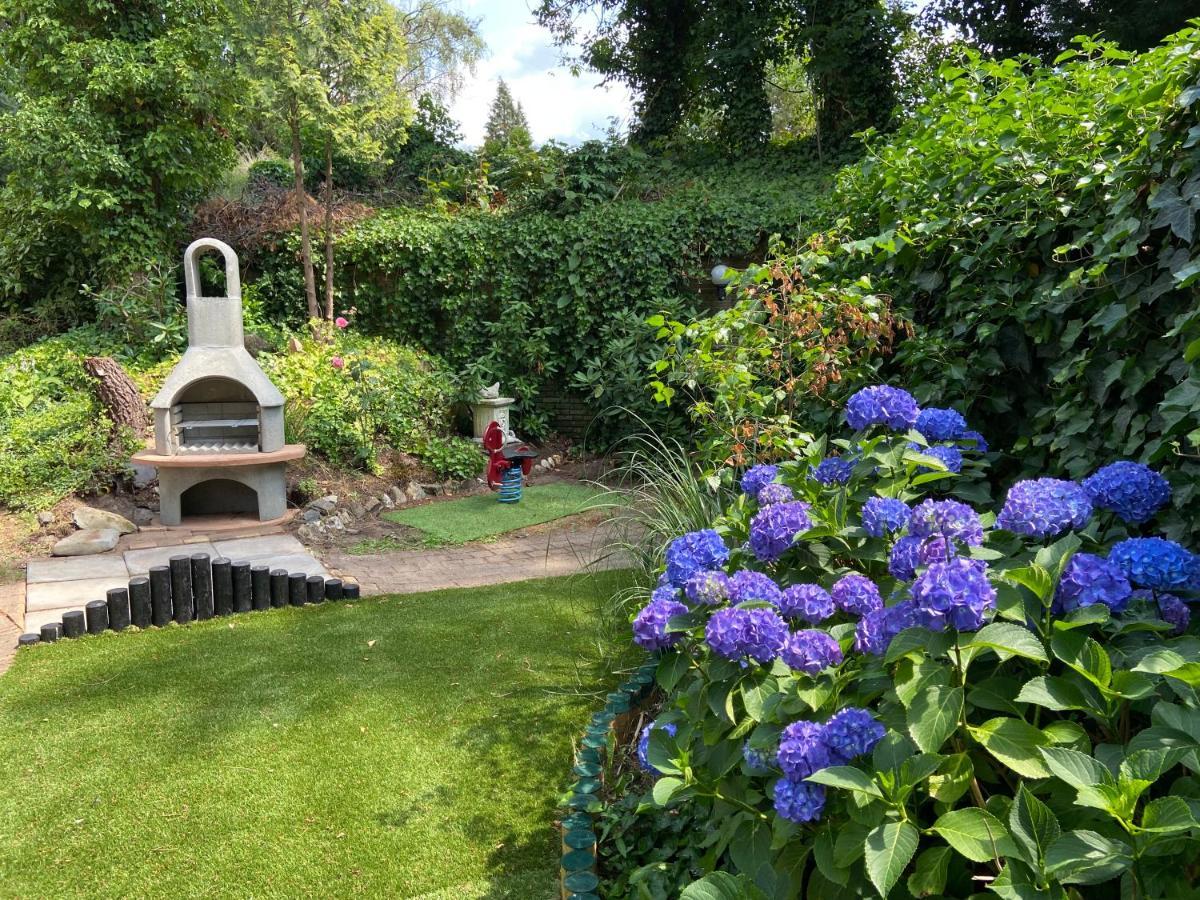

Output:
xmin=450 ymin=0 xmax=632 ymax=146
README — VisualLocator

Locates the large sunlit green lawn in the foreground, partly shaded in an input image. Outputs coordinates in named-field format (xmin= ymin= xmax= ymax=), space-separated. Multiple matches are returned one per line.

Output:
xmin=0 ymin=574 xmax=624 ymax=900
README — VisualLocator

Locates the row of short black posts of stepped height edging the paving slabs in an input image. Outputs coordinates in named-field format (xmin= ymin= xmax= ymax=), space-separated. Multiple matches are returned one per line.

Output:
xmin=17 ymin=553 xmax=359 ymax=647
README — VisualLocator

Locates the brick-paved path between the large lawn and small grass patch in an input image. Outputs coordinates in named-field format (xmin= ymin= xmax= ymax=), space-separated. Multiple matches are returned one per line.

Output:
xmin=320 ymin=523 xmax=624 ymax=596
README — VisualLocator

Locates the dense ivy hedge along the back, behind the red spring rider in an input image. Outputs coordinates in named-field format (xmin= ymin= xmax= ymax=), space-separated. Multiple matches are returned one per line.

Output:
xmin=254 ymin=161 xmax=832 ymax=448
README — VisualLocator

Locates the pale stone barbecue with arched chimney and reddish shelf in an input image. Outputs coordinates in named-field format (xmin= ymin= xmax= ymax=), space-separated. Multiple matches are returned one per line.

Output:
xmin=133 ymin=238 xmax=305 ymax=526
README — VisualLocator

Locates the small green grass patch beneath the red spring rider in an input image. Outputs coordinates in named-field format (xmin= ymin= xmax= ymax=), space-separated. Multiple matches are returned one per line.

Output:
xmin=384 ymin=482 xmax=601 ymax=544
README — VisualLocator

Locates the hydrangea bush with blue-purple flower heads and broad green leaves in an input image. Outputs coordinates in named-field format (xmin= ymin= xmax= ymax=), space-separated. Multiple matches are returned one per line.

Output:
xmin=619 ymin=385 xmax=1200 ymax=900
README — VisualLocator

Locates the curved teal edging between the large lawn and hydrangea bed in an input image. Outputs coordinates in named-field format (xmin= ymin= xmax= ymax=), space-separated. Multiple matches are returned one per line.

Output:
xmin=558 ymin=659 xmax=659 ymax=900
